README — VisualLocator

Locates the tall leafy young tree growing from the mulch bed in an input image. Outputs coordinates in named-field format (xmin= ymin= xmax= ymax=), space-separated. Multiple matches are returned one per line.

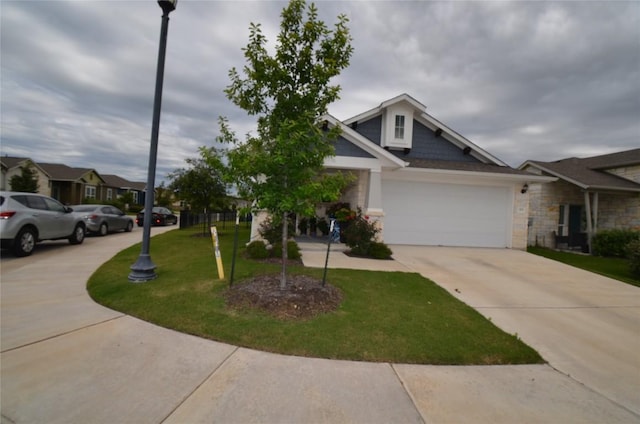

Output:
xmin=220 ymin=0 xmax=353 ymax=289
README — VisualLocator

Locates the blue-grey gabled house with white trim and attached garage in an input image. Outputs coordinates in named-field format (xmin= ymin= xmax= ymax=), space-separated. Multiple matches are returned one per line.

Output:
xmin=252 ymin=94 xmax=553 ymax=249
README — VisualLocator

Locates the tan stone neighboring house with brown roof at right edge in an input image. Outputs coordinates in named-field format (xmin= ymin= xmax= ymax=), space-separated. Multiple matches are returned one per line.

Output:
xmin=519 ymin=149 xmax=640 ymax=252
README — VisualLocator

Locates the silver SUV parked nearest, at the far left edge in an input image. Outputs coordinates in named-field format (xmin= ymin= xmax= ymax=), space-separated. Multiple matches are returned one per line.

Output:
xmin=0 ymin=191 xmax=86 ymax=256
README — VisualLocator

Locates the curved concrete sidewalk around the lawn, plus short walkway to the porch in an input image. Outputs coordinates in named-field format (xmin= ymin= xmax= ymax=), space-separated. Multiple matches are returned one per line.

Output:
xmin=0 ymin=234 xmax=640 ymax=424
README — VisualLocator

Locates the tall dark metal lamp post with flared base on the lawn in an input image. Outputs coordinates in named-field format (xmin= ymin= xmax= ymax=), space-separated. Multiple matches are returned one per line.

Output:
xmin=129 ymin=0 xmax=178 ymax=283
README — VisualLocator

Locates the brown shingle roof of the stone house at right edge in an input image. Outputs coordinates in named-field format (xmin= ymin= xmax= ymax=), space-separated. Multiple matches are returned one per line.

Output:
xmin=519 ymin=149 xmax=640 ymax=192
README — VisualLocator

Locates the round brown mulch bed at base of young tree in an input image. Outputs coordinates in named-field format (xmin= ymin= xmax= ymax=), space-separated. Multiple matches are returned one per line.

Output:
xmin=225 ymin=275 xmax=342 ymax=319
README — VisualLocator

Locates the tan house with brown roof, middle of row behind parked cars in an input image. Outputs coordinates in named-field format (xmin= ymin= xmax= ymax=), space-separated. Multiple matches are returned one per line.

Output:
xmin=38 ymin=162 xmax=105 ymax=205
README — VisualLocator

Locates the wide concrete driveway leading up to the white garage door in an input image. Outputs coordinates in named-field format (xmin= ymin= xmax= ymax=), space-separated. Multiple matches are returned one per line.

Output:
xmin=392 ymin=246 xmax=640 ymax=414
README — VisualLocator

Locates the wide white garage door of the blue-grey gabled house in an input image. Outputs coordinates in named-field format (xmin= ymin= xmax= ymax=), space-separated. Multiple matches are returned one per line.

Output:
xmin=382 ymin=180 xmax=512 ymax=247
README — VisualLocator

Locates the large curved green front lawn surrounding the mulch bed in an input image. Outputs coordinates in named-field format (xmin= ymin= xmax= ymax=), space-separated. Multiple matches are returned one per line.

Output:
xmin=88 ymin=228 xmax=543 ymax=364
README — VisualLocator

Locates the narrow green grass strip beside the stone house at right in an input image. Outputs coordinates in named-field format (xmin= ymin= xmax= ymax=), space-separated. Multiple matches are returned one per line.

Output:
xmin=527 ymin=247 xmax=640 ymax=287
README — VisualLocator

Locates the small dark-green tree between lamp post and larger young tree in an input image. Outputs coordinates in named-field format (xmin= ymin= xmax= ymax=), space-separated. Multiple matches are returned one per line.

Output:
xmin=169 ymin=147 xmax=227 ymax=234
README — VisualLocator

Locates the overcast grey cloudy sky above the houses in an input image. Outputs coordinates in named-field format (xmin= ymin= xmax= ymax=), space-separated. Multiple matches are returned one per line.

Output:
xmin=0 ymin=0 xmax=640 ymax=181
